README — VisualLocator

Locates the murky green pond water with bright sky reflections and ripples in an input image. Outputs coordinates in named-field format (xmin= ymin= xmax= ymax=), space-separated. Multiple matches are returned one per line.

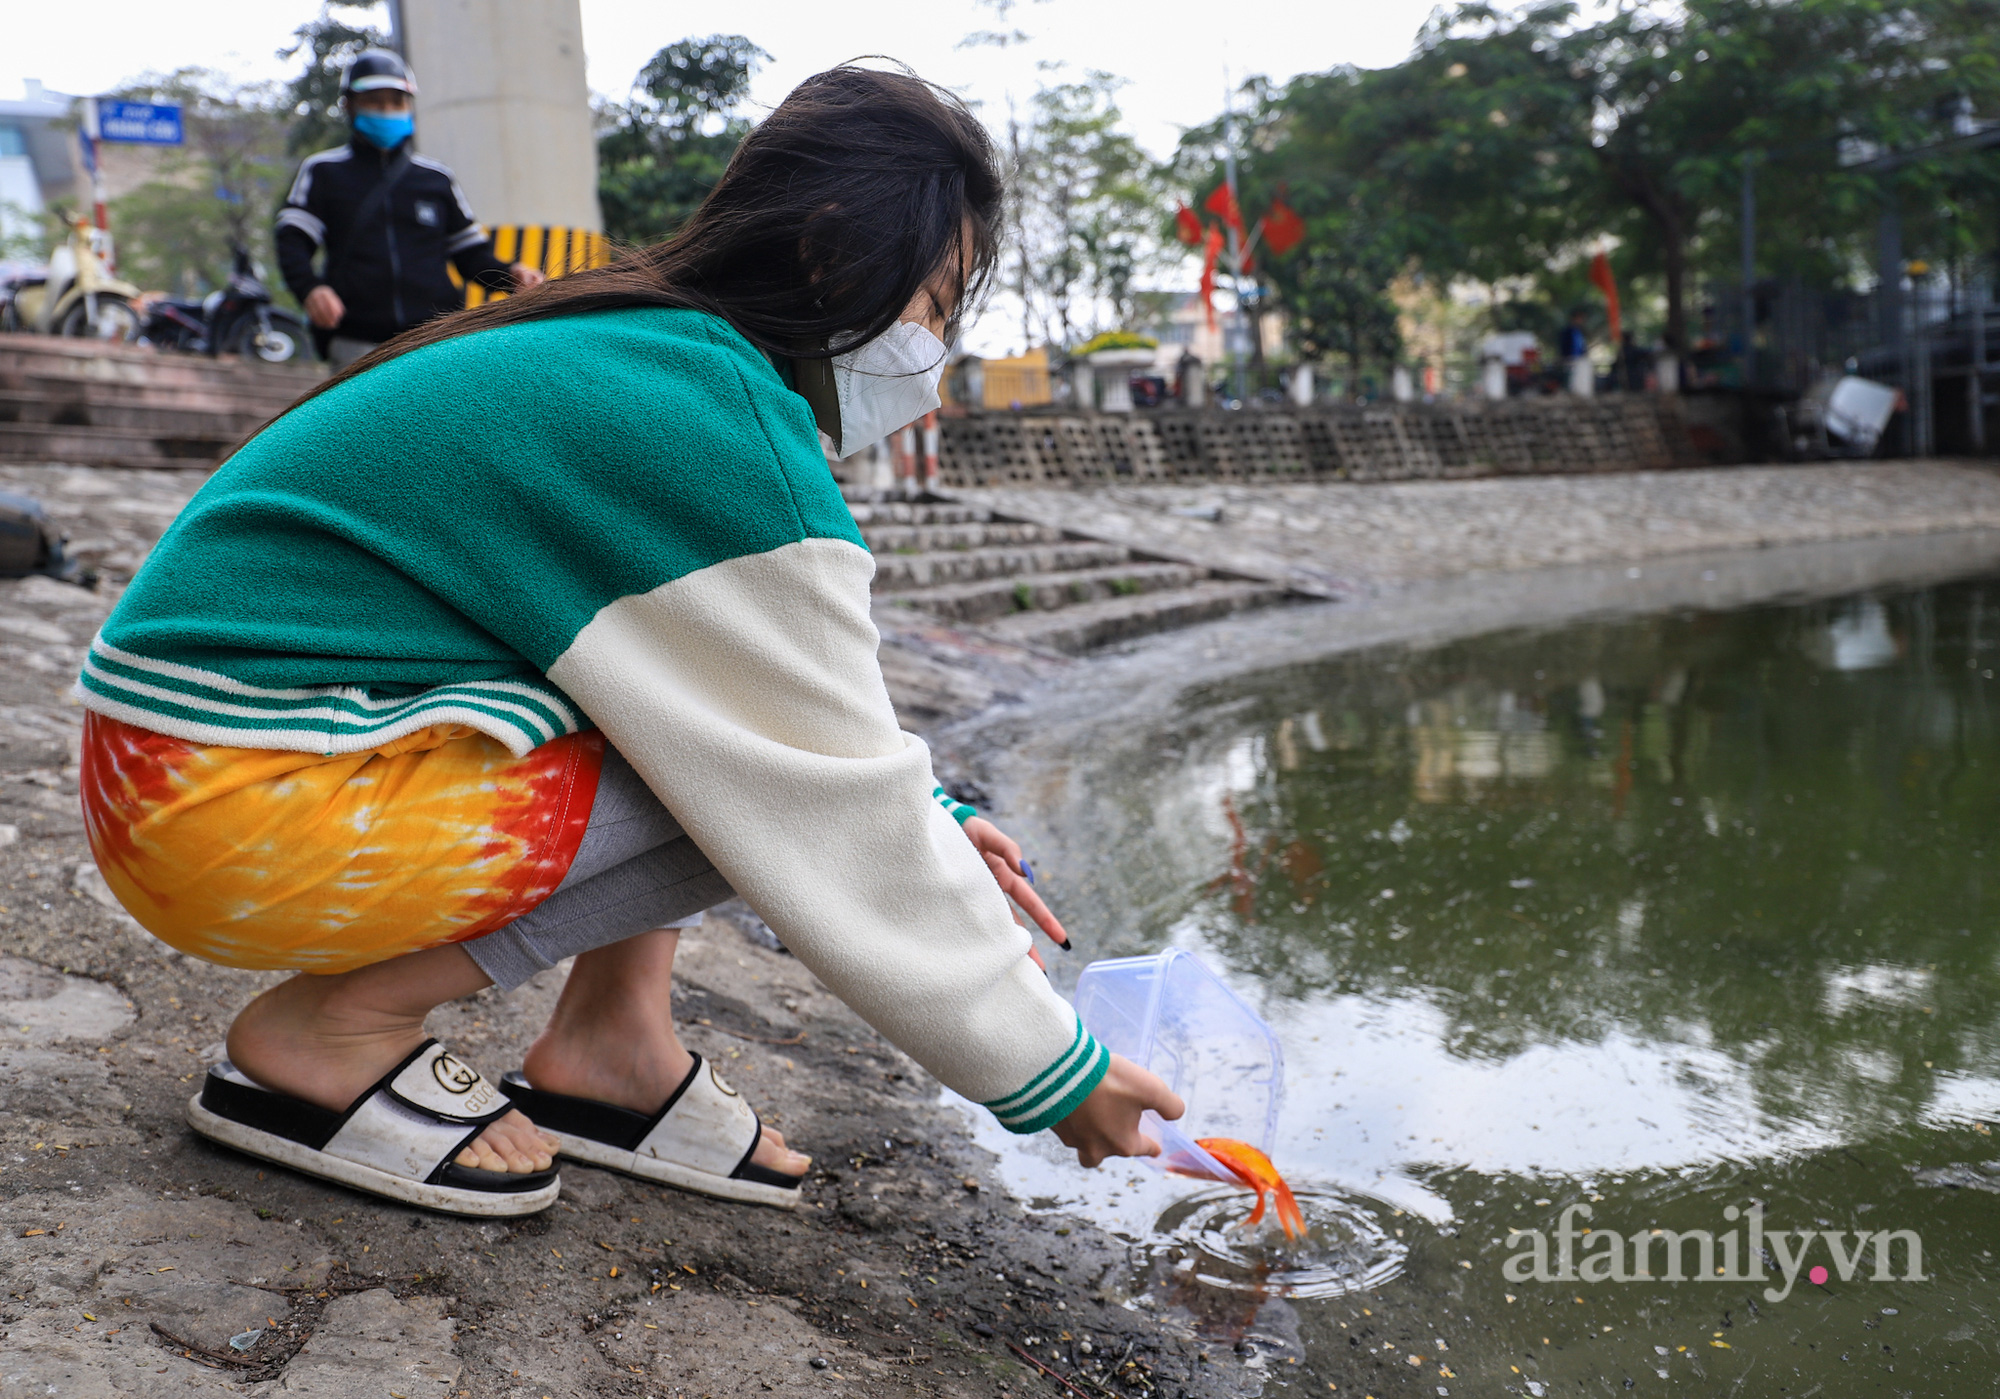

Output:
xmin=952 ymin=580 xmax=2000 ymax=1395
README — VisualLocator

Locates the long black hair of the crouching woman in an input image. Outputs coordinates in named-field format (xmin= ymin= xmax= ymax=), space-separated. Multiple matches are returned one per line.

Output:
xmin=286 ymin=64 xmax=1002 ymax=402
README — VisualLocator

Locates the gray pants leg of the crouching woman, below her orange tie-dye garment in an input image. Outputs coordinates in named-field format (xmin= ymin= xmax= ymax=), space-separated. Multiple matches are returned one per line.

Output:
xmin=462 ymin=745 xmax=734 ymax=991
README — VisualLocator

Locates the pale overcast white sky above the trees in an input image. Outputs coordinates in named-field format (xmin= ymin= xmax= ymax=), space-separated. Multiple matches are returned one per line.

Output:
xmin=0 ymin=0 xmax=1434 ymax=350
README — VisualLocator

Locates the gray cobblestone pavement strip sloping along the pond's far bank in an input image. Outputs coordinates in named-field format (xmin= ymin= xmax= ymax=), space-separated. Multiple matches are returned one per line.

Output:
xmin=954 ymin=462 xmax=2000 ymax=598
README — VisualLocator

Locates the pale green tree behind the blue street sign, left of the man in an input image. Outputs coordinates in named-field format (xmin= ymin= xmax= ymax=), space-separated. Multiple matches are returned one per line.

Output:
xmin=110 ymin=68 xmax=290 ymax=292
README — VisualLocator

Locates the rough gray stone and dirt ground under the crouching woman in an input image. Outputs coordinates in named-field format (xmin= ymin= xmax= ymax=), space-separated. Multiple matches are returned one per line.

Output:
xmin=0 ymin=468 xmax=1296 ymax=1399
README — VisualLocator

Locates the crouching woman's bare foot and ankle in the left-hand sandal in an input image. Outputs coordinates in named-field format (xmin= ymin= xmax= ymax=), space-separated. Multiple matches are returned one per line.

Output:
xmin=228 ymin=947 xmax=556 ymax=1175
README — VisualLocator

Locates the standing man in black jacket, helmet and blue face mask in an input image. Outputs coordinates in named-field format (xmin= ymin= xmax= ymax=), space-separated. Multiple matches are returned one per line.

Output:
xmin=276 ymin=48 xmax=542 ymax=368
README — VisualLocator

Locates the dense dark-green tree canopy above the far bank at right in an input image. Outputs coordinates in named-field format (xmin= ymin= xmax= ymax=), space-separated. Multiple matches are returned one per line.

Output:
xmin=1192 ymin=0 xmax=2000 ymax=357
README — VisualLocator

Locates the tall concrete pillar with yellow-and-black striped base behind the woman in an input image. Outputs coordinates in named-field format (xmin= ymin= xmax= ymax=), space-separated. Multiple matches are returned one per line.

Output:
xmin=396 ymin=0 xmax=604 ymax=257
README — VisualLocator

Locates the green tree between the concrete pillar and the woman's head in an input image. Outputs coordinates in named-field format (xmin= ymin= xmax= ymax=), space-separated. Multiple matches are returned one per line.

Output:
xmin=598 ymin=34 xmax=770 ymax=244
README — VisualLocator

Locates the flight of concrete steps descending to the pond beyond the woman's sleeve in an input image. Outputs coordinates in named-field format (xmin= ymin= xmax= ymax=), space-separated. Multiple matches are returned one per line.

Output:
xmin=848 ymin=492 xmax=1290 ymax=654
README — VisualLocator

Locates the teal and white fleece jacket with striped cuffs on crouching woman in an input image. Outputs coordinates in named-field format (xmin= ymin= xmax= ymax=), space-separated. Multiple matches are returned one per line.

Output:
xmin=78 ymin=310 xmax=1110 ymax=1131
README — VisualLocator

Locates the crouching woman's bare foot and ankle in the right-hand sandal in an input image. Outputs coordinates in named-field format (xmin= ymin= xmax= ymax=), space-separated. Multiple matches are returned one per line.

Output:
xmin=522 ymin=929 xmax=812 ymax=1175
